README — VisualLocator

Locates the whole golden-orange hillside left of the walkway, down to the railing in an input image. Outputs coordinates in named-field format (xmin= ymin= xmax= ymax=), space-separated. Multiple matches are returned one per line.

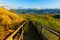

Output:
xmin=0 ymin=7 xmax=23 ymax=40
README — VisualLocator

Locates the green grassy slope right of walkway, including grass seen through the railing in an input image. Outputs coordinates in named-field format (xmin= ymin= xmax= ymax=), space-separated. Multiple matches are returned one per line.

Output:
xmin=20 ymin=14 xmax=60 ymax=40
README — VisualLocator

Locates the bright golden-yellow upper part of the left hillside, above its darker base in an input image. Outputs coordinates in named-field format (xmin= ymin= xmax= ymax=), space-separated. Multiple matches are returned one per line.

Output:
xmin=0 ymin=7 xmax=23 ymax=25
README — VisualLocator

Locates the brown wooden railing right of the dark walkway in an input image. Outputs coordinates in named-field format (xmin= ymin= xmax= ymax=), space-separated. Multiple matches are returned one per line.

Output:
xmin=32 ymin=20 xmax=60 ymax=40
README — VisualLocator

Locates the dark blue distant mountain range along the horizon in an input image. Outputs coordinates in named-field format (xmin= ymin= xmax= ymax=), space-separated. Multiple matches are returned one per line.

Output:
xmin=15 ymin=9 xmax=60 ymax=14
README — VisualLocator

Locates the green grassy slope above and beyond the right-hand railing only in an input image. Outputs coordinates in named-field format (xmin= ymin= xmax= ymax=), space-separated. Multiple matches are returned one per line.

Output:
xmin=23 ymin=14 xmax=60 ymax=32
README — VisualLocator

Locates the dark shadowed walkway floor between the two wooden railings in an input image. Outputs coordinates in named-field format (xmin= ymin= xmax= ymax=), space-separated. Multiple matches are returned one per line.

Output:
xmin=24 ymin=21 xmax=47 ymax=40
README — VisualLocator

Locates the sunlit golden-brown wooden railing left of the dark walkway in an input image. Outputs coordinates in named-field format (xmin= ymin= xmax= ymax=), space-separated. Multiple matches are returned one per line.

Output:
xmin=5 ymin=22 xmax=25 ymax=40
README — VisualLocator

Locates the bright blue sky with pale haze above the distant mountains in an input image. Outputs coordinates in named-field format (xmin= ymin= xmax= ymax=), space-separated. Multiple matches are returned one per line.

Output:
xmin=1 ymin=0 xmax=60 ymax=8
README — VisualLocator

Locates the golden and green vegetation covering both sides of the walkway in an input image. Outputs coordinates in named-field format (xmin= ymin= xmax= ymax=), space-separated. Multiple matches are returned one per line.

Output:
xmin=0 ymin=7 xmax=60 ymax=40
